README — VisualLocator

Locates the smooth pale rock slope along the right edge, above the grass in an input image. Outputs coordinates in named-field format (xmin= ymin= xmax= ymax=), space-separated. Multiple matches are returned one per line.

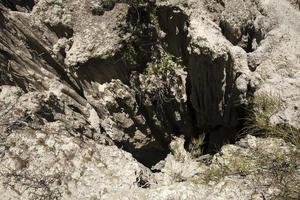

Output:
xmin=249 ymin=1 xmax=300 ymax=128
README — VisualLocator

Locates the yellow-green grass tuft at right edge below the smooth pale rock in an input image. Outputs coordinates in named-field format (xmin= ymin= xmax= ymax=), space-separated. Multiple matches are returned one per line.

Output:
xmin=243 ymin=93 xmax=300 ymax=147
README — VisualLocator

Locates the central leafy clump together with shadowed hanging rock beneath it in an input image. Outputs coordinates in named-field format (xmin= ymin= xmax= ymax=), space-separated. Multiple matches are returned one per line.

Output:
xmin=130 ymin=53 xmax=187 ymax=134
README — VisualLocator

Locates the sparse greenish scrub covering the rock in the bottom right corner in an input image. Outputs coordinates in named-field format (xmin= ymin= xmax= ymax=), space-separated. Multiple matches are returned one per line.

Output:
xmin=194 ymin=139 xmax=300 ymax=199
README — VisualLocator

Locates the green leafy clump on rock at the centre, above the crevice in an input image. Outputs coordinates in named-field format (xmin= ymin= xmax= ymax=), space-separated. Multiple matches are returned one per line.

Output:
xmin=129 ymin=52 xmax=185 ymax=106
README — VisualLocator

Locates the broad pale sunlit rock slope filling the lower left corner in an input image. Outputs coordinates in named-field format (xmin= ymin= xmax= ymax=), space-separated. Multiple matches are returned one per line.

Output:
xmin=0 ymin=86 xmax=154 ymax=199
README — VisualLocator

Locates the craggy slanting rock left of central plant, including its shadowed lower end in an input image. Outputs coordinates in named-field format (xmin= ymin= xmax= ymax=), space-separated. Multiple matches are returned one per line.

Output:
xmin=87 ymin=80 xmax=166 ymax=166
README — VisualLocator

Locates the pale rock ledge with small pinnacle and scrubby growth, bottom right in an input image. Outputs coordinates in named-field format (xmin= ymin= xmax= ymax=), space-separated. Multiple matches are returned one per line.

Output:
xmin=103 ymin=136 xmax=300 ymax=200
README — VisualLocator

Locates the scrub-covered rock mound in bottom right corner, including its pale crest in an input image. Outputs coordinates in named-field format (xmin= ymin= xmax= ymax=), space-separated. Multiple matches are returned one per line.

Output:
xmin=193 ymin=135 xmax=300 ymax=199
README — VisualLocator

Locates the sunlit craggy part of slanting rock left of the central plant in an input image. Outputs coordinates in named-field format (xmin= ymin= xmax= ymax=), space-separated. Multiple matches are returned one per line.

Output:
xmin=86 ymin=80 xmax=155 ymax=149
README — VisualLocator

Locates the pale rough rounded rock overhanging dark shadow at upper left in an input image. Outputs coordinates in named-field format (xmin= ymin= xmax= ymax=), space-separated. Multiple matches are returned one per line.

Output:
xmin=32 ymin=0 xmax=129 ymax=67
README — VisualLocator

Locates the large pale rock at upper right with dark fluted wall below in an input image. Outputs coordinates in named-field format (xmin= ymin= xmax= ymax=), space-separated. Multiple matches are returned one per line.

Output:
xmin=159 ymin=1 xmax=300 ymax=149
